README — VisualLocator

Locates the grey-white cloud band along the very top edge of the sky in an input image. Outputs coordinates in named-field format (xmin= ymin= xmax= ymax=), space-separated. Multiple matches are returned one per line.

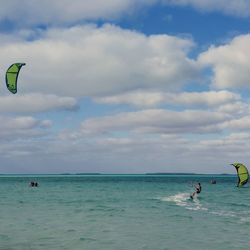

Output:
xmin=0 ymin=0 xmax=250 ymax=27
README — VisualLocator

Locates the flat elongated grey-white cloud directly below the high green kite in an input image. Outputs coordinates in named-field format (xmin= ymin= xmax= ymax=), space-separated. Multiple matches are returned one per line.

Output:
xmin=0 ymin=93 xmax=77 ymax=113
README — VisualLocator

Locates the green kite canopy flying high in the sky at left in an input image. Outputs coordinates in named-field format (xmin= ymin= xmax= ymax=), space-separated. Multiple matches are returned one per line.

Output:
xmin=5 ymin=63 xmax=25 ymax=94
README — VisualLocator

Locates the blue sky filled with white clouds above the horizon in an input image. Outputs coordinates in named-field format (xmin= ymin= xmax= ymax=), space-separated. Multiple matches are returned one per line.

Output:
xmin=0 ymin=0 xmax=250 ymax=174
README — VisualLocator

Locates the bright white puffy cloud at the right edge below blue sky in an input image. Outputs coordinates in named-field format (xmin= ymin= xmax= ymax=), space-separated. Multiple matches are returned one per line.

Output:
xmin=199 ymin=35 xmax=250 ymax=89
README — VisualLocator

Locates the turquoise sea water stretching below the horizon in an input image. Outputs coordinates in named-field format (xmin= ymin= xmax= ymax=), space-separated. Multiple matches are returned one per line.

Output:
xmin=0 ymin=175 xmax=250 ymax=250
